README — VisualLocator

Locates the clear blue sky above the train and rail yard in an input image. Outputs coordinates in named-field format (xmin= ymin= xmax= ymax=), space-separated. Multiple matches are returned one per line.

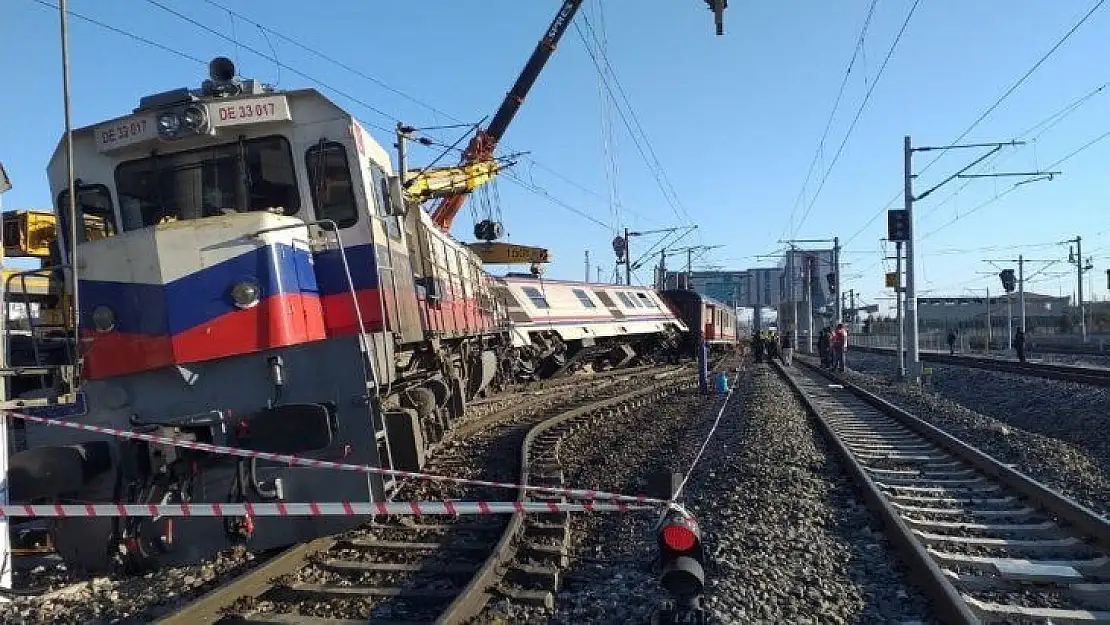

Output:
xmin=0 ymin=0 xmax=1110 ymax=313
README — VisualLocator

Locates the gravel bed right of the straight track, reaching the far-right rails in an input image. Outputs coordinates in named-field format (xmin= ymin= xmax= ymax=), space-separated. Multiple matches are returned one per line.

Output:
xmin=848 ymin=352 xmax=1110 ymax=515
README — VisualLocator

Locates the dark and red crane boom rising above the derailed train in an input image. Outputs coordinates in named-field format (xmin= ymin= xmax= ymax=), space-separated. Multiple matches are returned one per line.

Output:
xmin=432 ymin=0 xmax=583 ymax=230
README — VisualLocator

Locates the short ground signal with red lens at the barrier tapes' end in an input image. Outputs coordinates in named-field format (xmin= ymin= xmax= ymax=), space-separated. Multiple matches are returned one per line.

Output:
xmin=652 ymin=510 xmax=708 ymax=625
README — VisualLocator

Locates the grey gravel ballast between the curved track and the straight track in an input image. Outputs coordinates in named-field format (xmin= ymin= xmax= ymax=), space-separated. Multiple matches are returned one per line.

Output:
xmin=486 ymin=365 xmax=929 ymax=624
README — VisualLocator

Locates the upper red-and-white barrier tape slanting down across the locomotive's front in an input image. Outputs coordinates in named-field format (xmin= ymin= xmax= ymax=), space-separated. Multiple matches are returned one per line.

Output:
xmin=7 ymin=412 xmax=669 ymax=507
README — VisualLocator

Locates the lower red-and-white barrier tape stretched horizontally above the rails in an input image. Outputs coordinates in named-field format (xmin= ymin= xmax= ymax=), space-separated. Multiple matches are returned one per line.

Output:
xmin=0 ymin=501 xmax=655 ymax=518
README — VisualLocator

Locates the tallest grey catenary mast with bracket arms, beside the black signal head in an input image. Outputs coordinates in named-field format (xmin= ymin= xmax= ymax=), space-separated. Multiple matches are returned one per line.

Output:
xmin=902 ymin=134 xmax=1060 ymax=382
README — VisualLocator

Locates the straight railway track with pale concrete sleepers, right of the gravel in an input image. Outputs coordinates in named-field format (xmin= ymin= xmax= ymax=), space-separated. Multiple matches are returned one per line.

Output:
xmin=775 ymin=360 xmax=1110 ymax=624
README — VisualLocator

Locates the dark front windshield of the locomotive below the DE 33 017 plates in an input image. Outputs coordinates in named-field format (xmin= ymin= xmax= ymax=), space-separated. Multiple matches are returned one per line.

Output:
xmin=115 ymin=137 xmax=301 ymax=230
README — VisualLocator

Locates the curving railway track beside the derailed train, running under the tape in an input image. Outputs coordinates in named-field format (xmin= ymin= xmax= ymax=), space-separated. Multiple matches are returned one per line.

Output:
xmin=160 ymin=367 xmax=696 ymax=625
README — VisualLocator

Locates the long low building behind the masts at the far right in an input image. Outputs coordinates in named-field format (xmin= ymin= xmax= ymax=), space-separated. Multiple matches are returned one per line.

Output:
xmin=917 ymin=293 xmax=1071 ymax=333
